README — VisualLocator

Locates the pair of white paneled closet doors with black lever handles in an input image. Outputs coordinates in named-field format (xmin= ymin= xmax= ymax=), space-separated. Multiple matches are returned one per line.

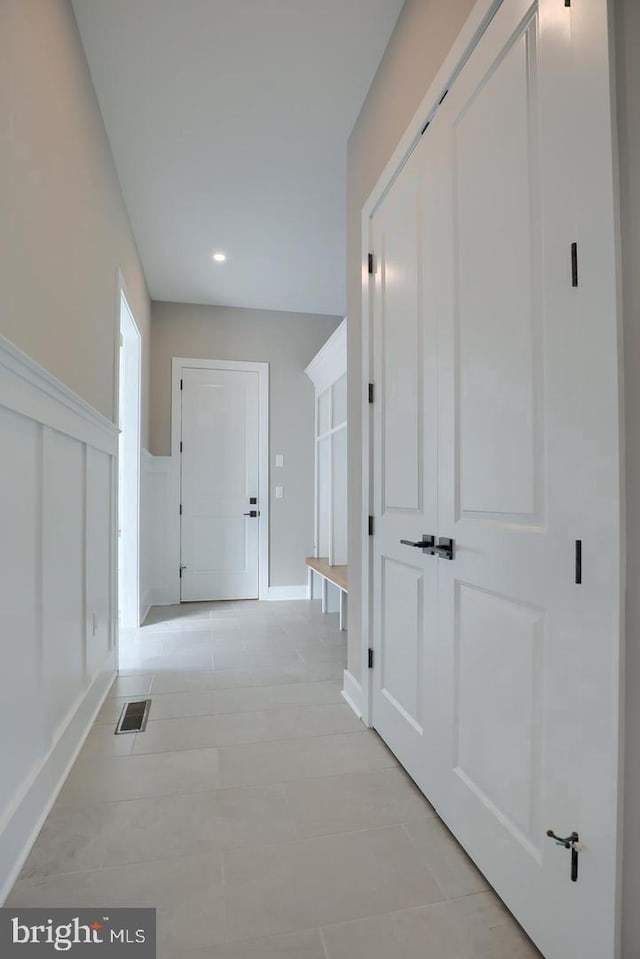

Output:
xmin=372 ymin=0 xmax=620 ymax=959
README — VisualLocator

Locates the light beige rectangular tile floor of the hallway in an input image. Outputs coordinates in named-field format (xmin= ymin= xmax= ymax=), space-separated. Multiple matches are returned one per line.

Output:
xmin=8 ymin=602 xmax=540 ymax=959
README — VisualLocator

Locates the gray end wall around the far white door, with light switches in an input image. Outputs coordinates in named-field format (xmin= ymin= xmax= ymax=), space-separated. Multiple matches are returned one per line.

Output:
xmin=151 ymin=303 xmax=342 ymax=586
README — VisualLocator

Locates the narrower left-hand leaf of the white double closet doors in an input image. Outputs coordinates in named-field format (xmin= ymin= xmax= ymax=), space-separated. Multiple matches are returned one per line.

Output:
xmin=372 ymin=131 xmax=437 ymax=793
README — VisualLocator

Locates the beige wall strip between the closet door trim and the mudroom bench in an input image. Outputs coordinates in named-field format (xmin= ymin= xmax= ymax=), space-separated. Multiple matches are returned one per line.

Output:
xmin=347 ymin=0 xmax=474 ymax=679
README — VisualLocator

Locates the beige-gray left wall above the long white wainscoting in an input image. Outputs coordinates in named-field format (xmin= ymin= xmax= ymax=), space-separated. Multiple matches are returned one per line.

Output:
xmin=0 ymin=0 xmax=149 ymax=443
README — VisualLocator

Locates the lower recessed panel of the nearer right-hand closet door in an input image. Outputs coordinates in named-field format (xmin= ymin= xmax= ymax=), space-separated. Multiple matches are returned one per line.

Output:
xmin=453 ymin=583 xmax=544 ymax=849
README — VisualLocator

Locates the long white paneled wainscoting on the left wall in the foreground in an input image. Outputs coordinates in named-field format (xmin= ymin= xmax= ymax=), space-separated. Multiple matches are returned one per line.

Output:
xmin=0 ymin=337 xmax=118 ymax=902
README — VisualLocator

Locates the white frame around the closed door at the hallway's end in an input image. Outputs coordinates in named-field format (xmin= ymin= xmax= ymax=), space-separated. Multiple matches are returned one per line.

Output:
xmin=171 ymin=356 xmax=269 ymax=603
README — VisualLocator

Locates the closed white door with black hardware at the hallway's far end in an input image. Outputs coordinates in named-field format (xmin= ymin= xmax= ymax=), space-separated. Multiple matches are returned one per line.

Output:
xmin=181 ymin=369 xmax=260 ymax=601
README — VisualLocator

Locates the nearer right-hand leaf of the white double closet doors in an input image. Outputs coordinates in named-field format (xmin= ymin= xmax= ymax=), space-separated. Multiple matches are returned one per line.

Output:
xmin=429 ymin=0 xmax=620 ymax=959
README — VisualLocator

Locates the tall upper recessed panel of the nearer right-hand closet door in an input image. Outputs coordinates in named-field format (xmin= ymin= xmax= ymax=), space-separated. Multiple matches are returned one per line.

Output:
xmin=451 ymin=24 xmax=544 ymax=522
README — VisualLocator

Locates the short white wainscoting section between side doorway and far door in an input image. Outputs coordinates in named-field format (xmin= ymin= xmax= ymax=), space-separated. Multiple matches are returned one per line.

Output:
xmin=140 ymin=450 xmax=180 ymax=622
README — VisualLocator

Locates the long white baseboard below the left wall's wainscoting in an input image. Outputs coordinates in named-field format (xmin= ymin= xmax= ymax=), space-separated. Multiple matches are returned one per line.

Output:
xmin=0 ymin=662 xmax=116 ymax=905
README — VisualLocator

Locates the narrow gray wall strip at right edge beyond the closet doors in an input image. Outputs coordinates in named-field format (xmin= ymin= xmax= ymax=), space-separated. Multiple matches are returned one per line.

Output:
xmin=614 ymin=0 xmax=640 ymax=959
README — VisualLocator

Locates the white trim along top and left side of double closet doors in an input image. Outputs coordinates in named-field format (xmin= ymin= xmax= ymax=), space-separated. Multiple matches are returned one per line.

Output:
xmin=360 ymin=0 xmax=502 ymax=726
